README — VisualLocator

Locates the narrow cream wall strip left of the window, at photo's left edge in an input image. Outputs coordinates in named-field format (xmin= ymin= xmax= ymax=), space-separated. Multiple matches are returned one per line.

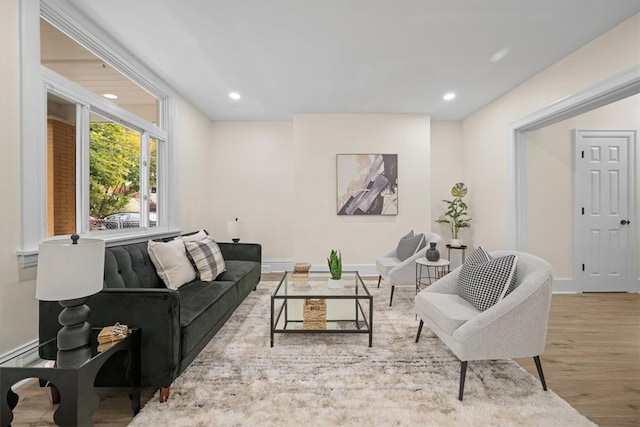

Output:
xmin=0 ymin=0 xmax=38 ymax=355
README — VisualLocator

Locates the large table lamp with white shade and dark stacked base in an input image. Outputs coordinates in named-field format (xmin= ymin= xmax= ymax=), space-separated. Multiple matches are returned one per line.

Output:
xmin=36 ymin=234 xmax=105 ymax=368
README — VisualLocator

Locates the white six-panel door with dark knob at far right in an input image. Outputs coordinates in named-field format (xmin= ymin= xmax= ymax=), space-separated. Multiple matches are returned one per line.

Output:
xmin=574 ymin=130 xmax=636 ymax=292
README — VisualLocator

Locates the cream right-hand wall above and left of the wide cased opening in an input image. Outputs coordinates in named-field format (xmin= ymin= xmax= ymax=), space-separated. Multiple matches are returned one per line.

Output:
xmin=463 ymin=14 xmax=640 ymax=260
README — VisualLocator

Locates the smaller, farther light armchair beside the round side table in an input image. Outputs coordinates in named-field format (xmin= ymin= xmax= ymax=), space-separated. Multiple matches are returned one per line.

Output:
xmin=376 ymin=232 xmax=442 ymax=306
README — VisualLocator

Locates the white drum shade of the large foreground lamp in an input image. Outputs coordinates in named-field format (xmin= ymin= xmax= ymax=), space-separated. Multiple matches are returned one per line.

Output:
xmin=36 ymin=239 xmax=105 ymax=301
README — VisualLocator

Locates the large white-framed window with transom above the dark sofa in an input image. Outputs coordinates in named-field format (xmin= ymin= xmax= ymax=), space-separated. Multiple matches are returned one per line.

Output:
xmin=18 ymin=0 xmax=176 ymax=266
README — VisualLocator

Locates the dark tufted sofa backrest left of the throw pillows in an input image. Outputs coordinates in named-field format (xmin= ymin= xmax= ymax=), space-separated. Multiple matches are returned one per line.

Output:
xmin=104 ymin=242 xmax=166 ymax=288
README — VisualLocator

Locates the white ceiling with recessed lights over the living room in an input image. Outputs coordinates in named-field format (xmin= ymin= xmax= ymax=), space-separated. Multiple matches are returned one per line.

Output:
xmin=61 ymin=0 xmax=640 ymax=120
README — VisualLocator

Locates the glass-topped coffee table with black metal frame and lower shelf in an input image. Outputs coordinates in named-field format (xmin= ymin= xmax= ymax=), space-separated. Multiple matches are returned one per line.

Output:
xmin=271 ymin=272 xmax=373 ymax=347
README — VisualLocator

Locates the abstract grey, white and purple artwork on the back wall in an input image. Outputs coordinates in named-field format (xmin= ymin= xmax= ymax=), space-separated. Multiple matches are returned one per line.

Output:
xmin=336 ymin=154 xmax=398 ymax=215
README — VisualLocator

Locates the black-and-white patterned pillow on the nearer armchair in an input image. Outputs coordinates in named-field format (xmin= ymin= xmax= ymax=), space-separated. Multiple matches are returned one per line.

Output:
xmin=458 ymin=255 xmax=518 ymax=311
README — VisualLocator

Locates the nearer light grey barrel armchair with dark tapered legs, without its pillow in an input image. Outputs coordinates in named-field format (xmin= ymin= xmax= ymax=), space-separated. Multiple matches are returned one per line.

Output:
xmin=415 ymin=251 xmax=553 ymax=400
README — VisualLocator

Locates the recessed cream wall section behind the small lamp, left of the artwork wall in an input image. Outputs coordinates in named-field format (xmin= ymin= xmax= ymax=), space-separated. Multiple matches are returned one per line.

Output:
xmin=207 ymin=122 xmax=296 ymax=263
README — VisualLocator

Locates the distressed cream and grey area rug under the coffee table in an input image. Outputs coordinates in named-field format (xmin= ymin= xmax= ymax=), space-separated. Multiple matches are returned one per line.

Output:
xmin=130 ymin=281 xmax=594 ymax=427
